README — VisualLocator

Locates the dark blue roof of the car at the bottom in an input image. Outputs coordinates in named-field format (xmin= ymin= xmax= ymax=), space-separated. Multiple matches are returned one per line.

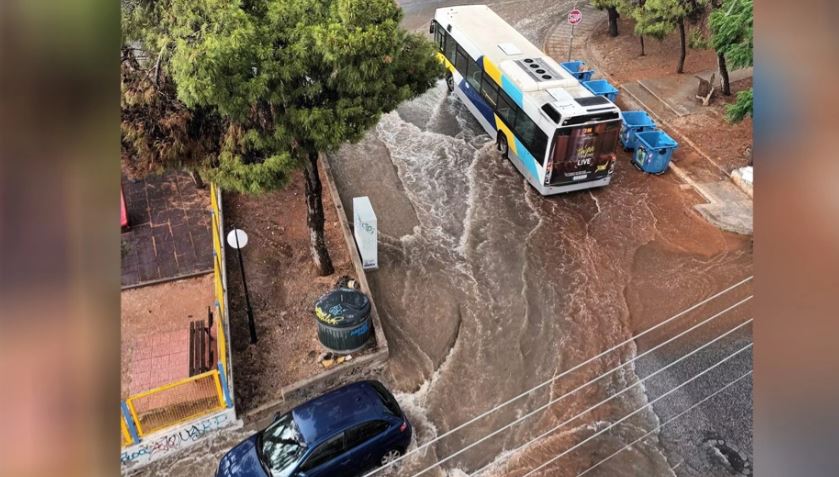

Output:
xmin=291 ymin=381 xmax=392 ymax=447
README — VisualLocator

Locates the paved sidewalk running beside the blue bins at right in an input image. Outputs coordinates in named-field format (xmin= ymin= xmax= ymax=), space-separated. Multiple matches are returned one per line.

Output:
xmin=543 ymin=10 xmax=753 ymax=235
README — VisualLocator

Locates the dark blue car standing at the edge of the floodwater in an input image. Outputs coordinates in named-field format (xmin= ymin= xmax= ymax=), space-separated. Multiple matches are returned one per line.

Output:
xmin=216 ymin=381 xmax=412 ymax=477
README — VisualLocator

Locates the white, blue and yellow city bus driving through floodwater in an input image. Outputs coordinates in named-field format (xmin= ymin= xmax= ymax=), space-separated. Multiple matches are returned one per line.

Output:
xmin=430 ymin=5 xmax=621 ymax=195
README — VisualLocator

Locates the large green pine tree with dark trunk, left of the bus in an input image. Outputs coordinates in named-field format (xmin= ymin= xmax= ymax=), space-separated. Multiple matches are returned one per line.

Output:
xmin=124 ymin=0 xmax=442 ymax=275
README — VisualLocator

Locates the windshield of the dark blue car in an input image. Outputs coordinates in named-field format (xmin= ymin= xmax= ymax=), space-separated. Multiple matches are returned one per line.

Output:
xmin=259 ymin=414 xmax=306 ymax=477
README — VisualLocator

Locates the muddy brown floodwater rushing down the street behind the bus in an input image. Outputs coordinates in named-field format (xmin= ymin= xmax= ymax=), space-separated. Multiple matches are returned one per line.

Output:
xmin=330 ymin=2 xmax=751 ymax=476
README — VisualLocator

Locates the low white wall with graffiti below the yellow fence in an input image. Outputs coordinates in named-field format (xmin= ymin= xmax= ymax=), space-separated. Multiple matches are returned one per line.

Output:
xmin=119 ymin=409 xmax=235 ymax=467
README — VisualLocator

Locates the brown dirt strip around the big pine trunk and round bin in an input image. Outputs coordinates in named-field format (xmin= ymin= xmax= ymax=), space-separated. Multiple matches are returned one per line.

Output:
xmin=223 ymin=165 xmax=354 ymax=412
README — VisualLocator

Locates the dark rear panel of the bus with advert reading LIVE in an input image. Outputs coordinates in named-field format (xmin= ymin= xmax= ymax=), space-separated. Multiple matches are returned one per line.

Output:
xmin=549 ymin=119 xmax=620 ymax=185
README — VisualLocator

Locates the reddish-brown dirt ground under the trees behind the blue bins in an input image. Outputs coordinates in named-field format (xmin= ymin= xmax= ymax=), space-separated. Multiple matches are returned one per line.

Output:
xmin=587 ymin=18 xmax=752 ymax=171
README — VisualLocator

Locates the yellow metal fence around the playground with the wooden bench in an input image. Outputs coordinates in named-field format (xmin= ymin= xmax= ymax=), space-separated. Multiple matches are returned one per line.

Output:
xmin=120 ymin=183 xmax=232 ymax=446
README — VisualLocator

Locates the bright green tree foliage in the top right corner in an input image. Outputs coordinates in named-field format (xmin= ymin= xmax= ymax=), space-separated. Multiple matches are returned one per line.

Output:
xmin=708 ymin=0 xmax=754 ymax=68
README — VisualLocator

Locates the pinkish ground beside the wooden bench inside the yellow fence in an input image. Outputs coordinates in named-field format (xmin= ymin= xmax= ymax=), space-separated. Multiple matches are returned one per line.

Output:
xmin=120 ymin=273 xmax=214 ymax=399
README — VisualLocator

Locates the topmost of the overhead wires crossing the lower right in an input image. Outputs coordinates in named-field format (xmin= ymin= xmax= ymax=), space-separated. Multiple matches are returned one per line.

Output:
xmin=363 ymin=275 xmax=754 ymax=477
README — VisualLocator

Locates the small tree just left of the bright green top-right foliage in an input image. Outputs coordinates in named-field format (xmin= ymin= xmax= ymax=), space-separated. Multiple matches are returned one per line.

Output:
xmin=633 ymin=0 xmax=706 ymax=74
